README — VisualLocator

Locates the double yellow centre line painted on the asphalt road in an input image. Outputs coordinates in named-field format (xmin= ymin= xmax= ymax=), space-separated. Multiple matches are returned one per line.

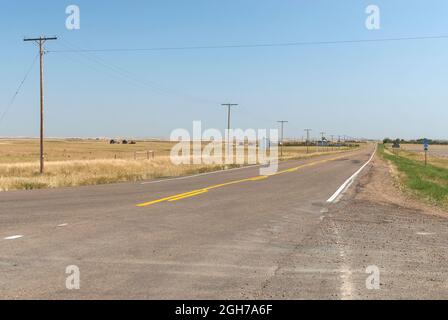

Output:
xmin=137 ymin=154 xmax=347 ymax=207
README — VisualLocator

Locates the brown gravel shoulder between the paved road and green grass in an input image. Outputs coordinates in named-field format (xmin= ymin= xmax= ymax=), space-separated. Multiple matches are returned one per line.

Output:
xmin=321 ymin=156 xmax=448 ymax=299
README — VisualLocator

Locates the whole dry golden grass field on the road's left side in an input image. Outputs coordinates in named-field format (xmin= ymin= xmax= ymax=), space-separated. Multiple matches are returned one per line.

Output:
xmin=0 ymin=139 xmax=356 ymax=191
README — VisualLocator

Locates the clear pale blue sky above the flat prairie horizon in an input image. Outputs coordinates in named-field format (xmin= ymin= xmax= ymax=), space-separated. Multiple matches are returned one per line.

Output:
xmin=0 ymin=0 xmax=448 ymax=138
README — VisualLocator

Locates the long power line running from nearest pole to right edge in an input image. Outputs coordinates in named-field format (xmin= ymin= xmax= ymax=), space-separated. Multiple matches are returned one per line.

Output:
xmin=49 ymin=35 xmax=448 ymax=53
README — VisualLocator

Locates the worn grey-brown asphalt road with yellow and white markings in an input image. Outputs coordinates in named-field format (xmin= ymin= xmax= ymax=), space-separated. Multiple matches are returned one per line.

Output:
xmin=0 ymin=145 xmax=426 ymax=299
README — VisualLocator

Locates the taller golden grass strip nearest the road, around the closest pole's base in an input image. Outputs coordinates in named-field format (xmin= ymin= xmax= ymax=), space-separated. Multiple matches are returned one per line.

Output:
xmin=0 ymin=158 xmax=229 ymax=191
